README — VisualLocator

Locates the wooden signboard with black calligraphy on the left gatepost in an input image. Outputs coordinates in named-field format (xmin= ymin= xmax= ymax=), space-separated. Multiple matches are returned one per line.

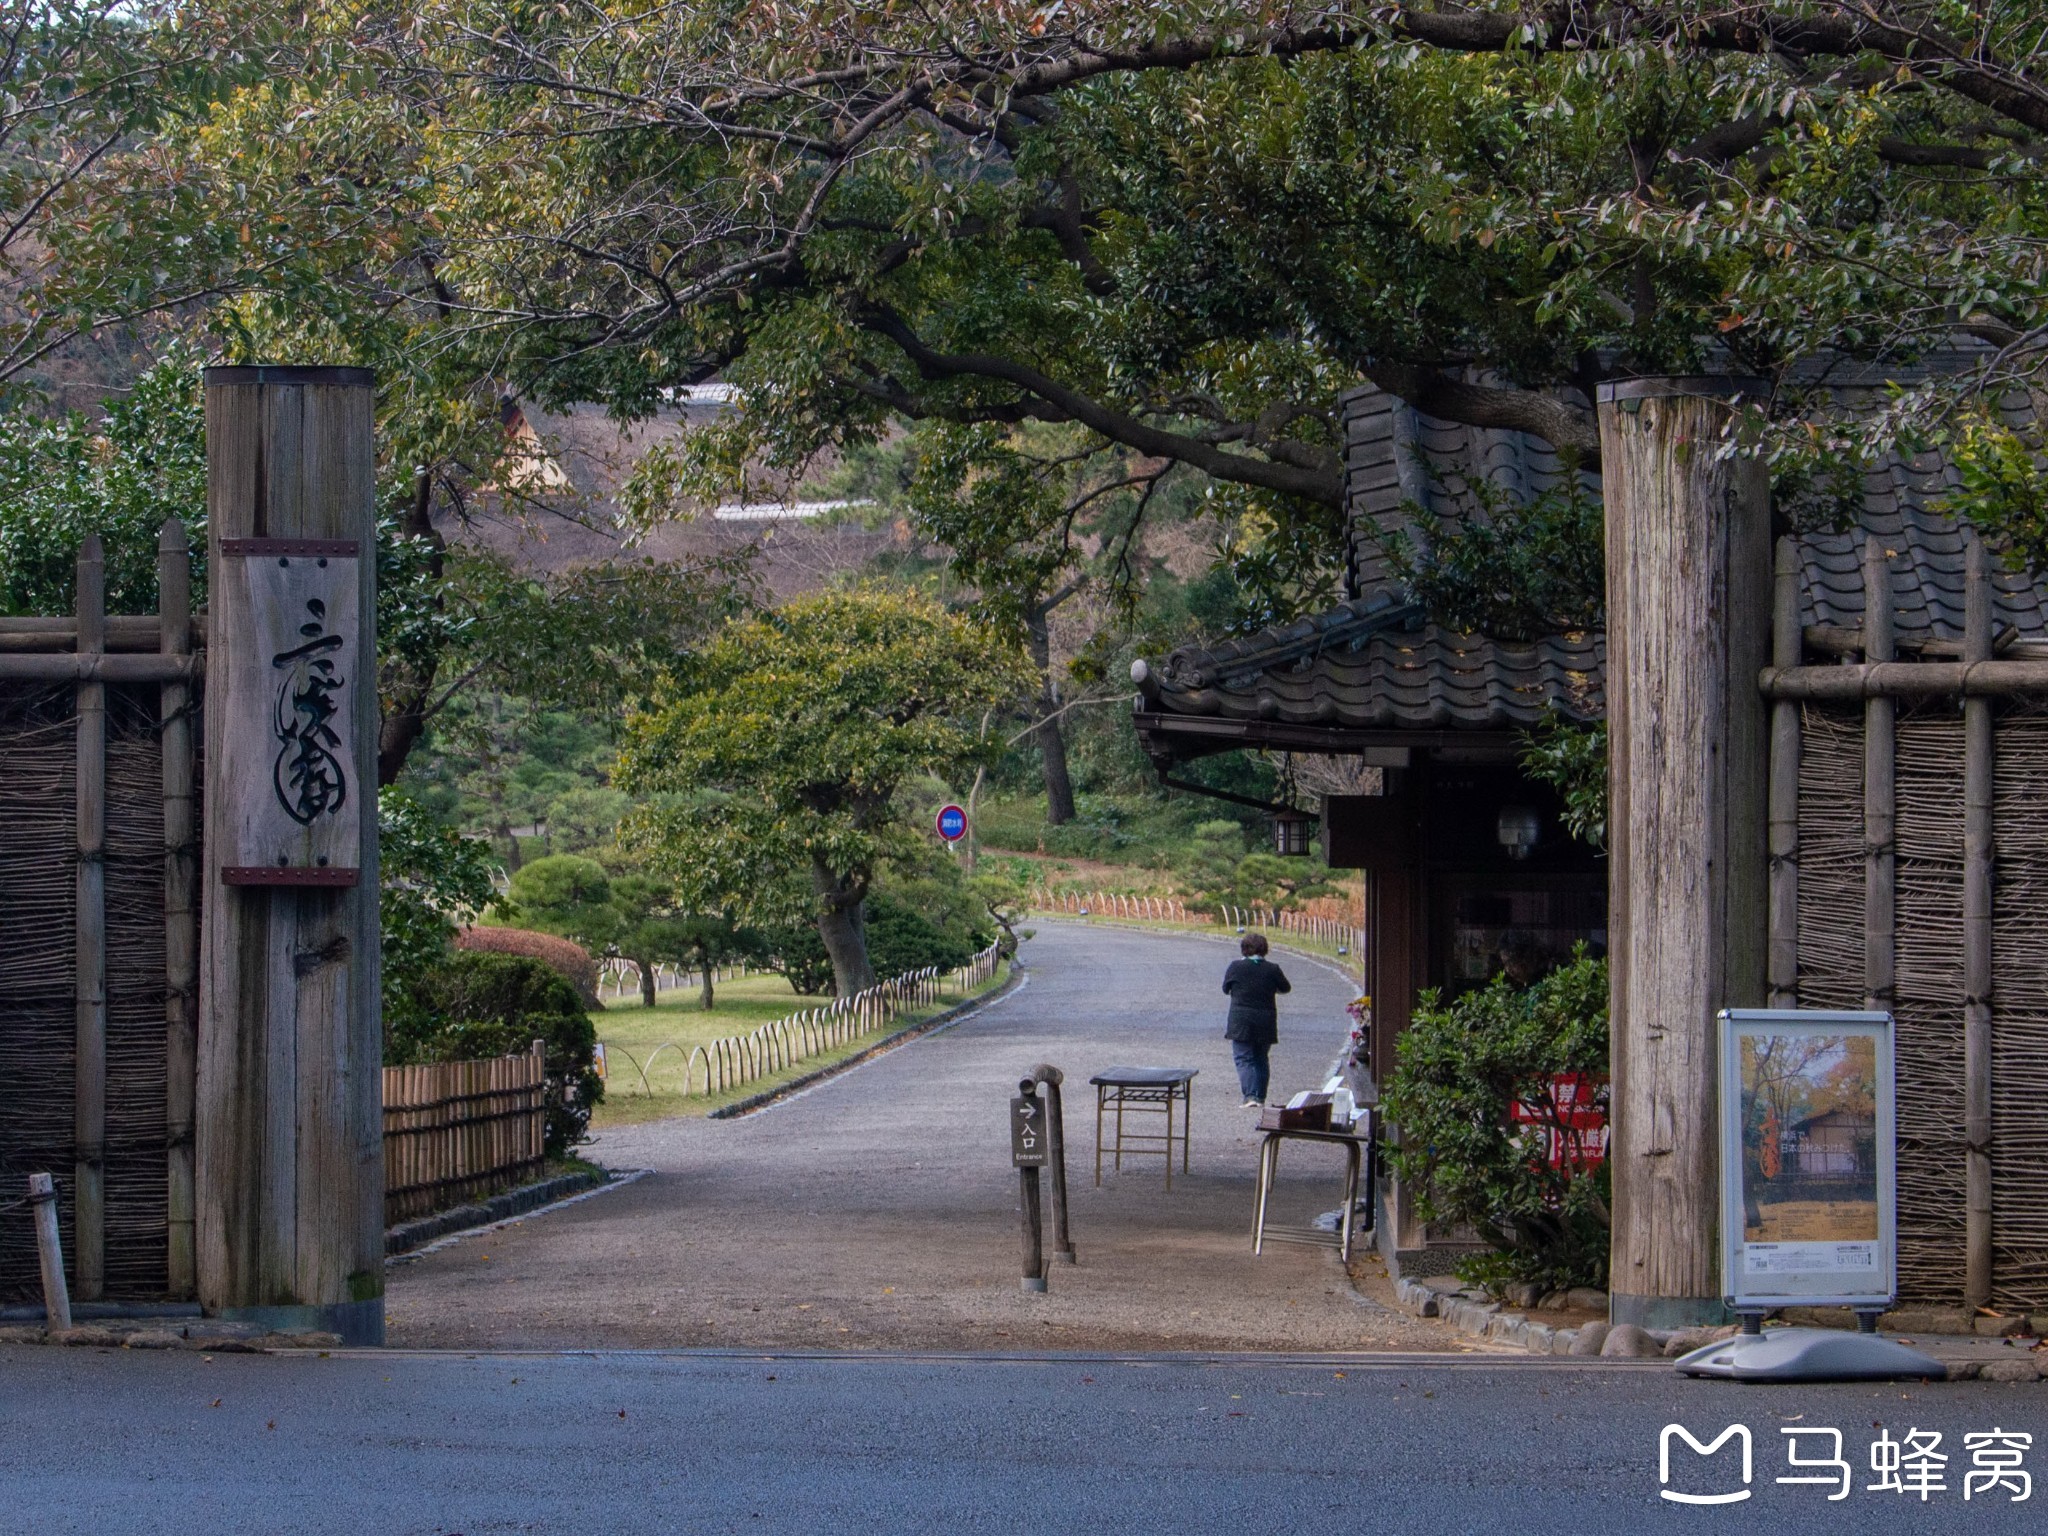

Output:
xmin=213 ymin=539 xmax=373 ymax=885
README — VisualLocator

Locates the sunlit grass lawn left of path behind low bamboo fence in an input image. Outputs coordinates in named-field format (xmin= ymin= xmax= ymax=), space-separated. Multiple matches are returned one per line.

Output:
xmin=592 ymin=967 xmax=1008 ymax=1130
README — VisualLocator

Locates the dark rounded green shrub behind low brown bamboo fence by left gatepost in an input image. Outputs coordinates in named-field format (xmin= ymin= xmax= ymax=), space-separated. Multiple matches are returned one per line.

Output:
xmin=385 ymin=950 xmax=604 ymax=1157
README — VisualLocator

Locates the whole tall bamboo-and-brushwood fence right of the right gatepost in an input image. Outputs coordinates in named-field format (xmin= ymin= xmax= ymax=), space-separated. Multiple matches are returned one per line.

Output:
xmin=1763 ymin=541 xmax=2048 ymax=1309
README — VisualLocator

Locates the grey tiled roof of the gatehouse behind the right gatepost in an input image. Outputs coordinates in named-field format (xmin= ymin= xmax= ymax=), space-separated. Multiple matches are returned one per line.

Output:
xmin=1133 ymin=381 xmax=2048 ymax=753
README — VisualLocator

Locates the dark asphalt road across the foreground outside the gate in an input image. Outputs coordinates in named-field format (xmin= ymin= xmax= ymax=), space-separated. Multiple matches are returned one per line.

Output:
xmin=0 ymin=1348 xmax=2048 ymax=1536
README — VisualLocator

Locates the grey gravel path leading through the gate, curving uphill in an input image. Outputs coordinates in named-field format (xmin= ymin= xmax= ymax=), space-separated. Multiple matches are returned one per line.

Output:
xmin=389 ymin=924 xmax=1468 ymax=1350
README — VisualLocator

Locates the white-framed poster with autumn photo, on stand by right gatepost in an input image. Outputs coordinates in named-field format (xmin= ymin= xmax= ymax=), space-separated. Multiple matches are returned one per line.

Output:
xmin=1720 ymin=1008 xmax=1898 ymax=1311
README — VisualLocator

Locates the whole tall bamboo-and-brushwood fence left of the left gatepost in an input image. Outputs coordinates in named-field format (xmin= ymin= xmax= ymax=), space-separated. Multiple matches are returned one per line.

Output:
xmin=0 ymin=522 xmax=205 ymax=1300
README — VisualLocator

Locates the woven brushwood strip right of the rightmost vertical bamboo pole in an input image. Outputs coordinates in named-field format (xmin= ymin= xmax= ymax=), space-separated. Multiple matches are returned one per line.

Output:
xmin=1991 ymin=711 xmax=2048 ymax=1309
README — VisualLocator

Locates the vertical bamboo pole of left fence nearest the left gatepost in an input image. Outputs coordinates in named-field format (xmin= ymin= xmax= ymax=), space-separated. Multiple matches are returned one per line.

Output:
xmin=156 ymin=518 xmax=199 ymax=1300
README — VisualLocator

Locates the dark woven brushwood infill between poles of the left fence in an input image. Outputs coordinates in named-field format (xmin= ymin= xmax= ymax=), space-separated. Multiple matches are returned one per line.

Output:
xmin=0 ymin=686 xmax=168 ymax=1300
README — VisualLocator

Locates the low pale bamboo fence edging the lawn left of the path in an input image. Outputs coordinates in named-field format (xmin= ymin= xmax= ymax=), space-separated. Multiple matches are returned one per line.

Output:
xmin=602 ymin=944 xmax=1001 ymax=1098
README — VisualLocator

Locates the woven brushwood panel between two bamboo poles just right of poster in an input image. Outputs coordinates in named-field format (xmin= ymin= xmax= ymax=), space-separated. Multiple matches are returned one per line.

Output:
xmin=1892 ymin=705 xmax=1966 ymax=1305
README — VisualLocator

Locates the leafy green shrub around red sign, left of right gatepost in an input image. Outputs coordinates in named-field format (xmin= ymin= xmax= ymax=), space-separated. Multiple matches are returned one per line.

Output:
xmin=1384 ymin=944 xmax=1610 ymax=1286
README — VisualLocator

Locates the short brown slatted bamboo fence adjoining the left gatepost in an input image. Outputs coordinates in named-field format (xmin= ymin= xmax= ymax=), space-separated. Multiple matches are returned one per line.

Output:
xmin=383 ymin=1040 xmax=547 ymax=1225
